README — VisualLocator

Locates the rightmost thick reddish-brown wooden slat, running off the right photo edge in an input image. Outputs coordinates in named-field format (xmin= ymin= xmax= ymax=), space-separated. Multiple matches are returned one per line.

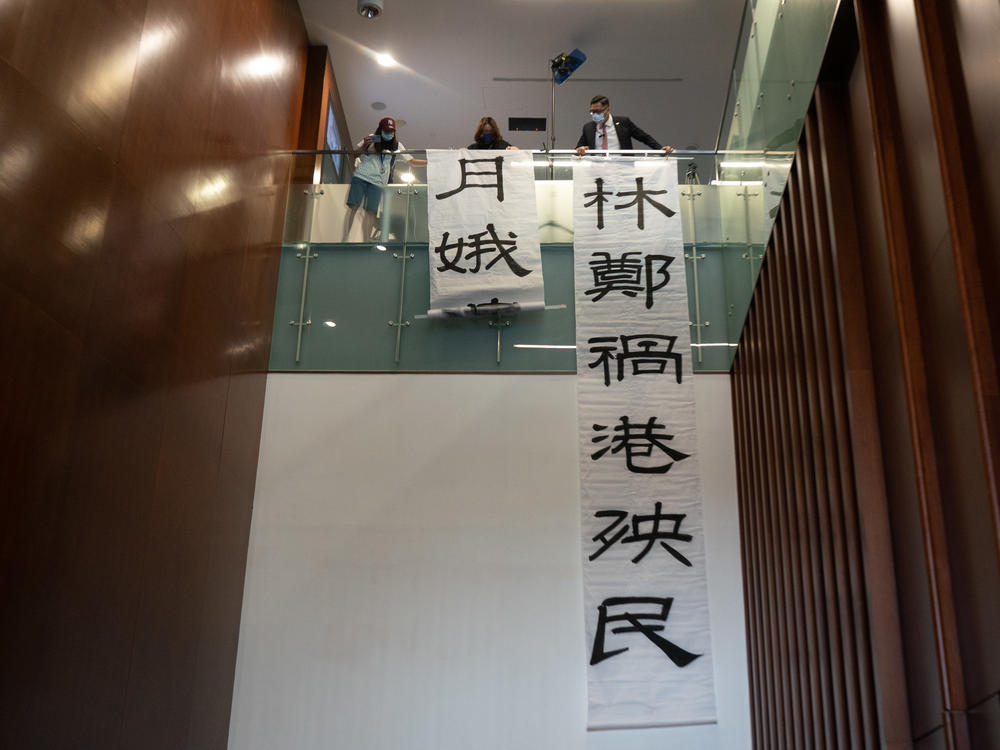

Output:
xmin=914 ymin=0 xmax=1000 ymax=557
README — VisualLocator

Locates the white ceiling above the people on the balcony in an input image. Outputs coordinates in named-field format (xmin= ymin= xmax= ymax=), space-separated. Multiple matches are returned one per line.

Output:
xmin=300 ymin=0 xmax=744 ymax=149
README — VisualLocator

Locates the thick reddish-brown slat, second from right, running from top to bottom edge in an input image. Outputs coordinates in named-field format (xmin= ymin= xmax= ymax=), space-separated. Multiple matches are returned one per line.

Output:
xmin=854 ymin=0 xmax=970 ymax=750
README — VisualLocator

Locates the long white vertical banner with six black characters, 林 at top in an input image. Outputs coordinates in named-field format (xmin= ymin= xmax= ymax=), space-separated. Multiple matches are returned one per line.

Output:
xmin=573 ymin=157 xmax=715 ymax=729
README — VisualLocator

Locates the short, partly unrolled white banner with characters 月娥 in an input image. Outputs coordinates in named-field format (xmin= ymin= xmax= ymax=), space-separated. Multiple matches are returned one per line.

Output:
xmin=427 ymin=149 xmax=545 ymax=314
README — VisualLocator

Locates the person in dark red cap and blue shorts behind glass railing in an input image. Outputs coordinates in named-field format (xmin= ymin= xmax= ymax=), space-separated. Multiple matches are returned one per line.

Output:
xmin=343 ymin=117 xmax=427 ymax=242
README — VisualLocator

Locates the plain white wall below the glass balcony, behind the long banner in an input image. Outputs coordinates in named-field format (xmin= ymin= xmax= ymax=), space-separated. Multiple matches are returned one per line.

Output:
xmin=229 ymin=374 xmax=750 ymax=750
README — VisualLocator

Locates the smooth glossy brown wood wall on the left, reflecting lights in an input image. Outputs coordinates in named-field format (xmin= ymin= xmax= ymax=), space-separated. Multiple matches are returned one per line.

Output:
xmin=0 ymin=0 xmax=307 ymax=750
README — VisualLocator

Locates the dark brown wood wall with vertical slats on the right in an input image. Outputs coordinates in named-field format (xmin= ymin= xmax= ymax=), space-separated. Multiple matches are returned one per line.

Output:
xmin=733 ymin=0 xmax=1000 ymax=750
